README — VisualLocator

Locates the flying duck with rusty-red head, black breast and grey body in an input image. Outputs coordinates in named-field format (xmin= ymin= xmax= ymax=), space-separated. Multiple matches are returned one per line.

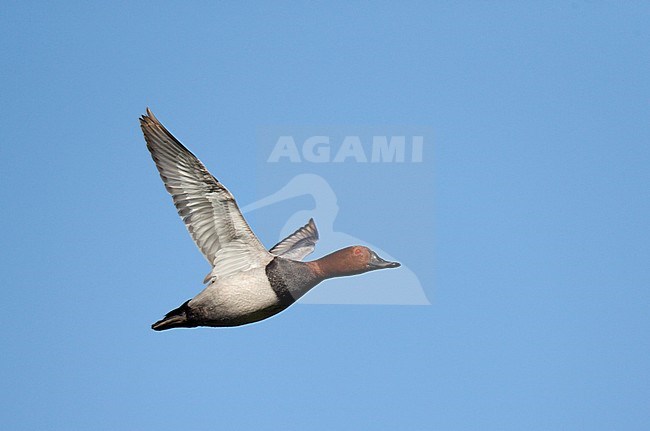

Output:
xmin=140 ymin=108 xmax=400 ymax=331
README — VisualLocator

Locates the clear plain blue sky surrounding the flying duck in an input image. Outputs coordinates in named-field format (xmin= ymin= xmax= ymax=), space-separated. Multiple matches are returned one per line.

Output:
xmin=0 ymin=1 xmax=650 ymax=430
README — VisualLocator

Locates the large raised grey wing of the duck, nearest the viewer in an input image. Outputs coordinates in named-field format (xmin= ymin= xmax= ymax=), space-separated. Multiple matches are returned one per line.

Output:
xmin=140 ymin=108 xmax=272 ymax=278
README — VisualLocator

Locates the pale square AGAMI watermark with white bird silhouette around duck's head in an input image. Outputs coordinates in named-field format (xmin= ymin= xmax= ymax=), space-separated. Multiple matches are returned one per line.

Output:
xmin=242 ymin=127 xmax=433 ymax=305
